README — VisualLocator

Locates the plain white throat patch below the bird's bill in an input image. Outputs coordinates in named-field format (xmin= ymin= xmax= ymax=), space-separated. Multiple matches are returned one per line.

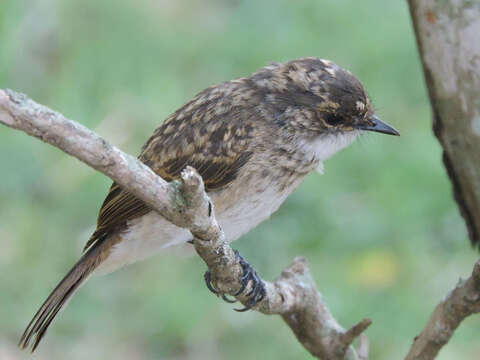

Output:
xmin=299 ymin=131 xmax=358 ymax=174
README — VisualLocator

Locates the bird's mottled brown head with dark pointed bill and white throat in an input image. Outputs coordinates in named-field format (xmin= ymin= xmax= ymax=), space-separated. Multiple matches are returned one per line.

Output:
xmin=251 ymin=58 xmax=400 ymax=160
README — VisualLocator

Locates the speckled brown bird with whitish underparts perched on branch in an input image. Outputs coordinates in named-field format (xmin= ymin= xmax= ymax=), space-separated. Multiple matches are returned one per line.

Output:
xmin=19 ymin=57 xmax=399 ymax=352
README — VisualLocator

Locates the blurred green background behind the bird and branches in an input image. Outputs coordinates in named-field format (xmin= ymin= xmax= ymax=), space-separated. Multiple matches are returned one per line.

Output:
xmin=0 ymin=0 xmax=480 ymax=360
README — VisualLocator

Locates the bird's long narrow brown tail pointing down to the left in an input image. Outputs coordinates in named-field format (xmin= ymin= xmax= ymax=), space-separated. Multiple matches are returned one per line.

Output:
xmin=18 ymin=239 xmax=111 ymax=352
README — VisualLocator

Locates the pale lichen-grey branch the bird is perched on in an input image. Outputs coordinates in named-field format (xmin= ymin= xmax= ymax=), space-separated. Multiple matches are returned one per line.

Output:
xmin=0 ymin=90 xmax=371 ymax=360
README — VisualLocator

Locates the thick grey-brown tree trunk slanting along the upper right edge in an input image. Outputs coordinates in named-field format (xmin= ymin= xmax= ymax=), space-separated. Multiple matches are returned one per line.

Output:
xmin=408 ymin=0 xmax=480 ymax=247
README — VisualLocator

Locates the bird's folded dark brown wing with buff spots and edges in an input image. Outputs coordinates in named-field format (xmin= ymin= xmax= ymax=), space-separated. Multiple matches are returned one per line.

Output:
xmin=84 ymin=88 xmax=255 ymax=250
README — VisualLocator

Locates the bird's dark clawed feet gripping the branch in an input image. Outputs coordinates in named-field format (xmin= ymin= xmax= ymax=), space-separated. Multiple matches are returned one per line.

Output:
xmin=204 ymin=250 xmax=266 ymax=312
